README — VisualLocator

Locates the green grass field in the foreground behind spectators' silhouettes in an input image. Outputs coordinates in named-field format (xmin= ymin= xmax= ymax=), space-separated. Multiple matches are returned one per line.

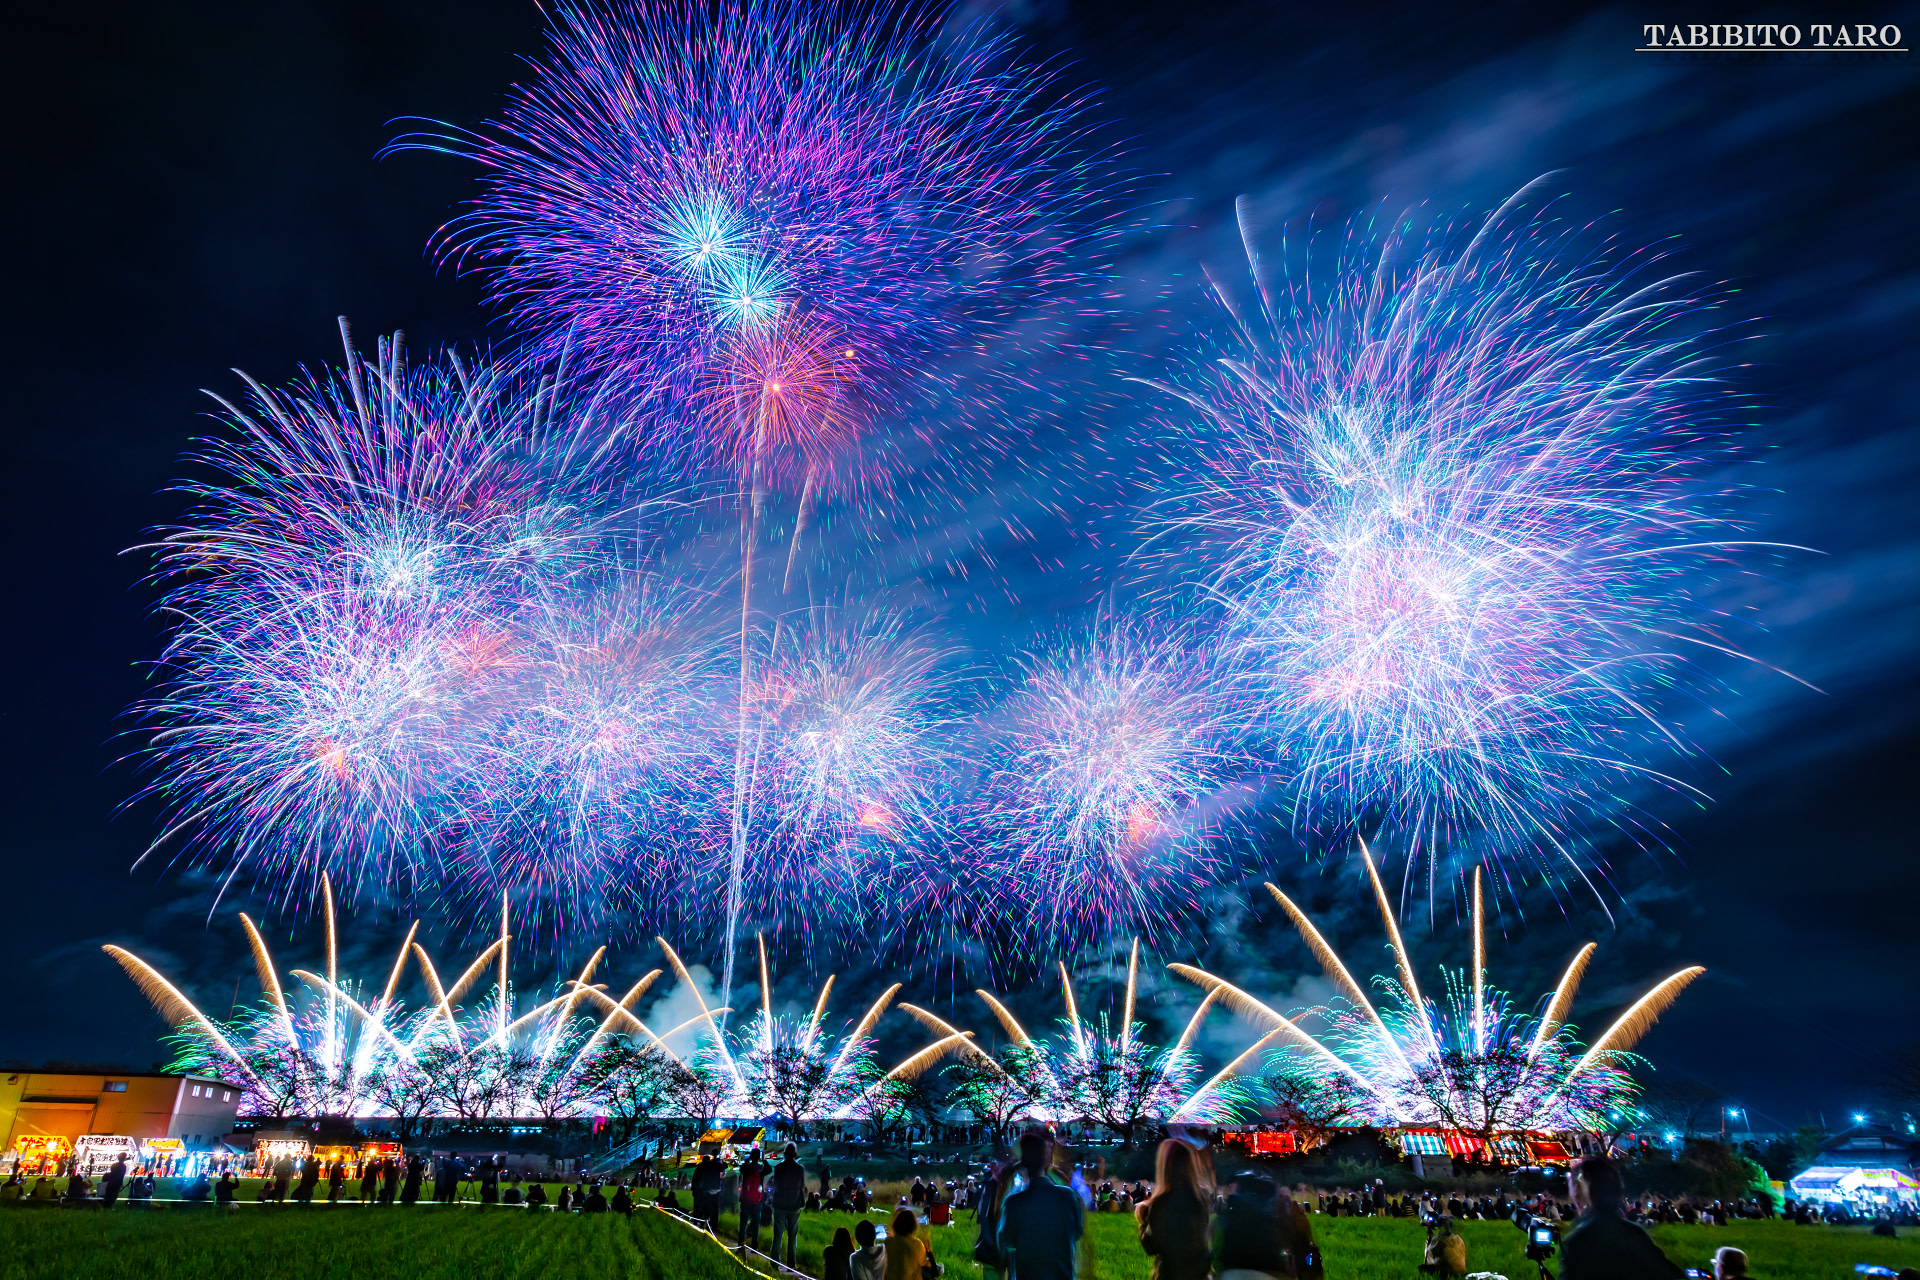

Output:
xmin=0 ymin=1186 xmax=1920 ymax=1280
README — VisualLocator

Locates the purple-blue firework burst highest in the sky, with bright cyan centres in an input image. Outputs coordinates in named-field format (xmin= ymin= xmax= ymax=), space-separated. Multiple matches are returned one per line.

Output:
xmin=396 ymin=0 xmax=1110 ymax=486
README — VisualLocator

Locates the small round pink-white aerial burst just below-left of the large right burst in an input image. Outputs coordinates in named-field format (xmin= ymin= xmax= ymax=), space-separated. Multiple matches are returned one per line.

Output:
xmin=977 ymin=622 xmax=1246 ymax=950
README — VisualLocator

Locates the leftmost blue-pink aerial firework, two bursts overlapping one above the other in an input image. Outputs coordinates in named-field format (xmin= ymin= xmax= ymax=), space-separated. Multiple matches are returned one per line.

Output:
xmin=136 ymin=330 xmax=629 ymax=909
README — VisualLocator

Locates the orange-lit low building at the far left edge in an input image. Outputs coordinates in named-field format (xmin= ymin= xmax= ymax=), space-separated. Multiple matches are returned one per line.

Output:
xmin=0 ymin=1071 xmax=240 ymax=1151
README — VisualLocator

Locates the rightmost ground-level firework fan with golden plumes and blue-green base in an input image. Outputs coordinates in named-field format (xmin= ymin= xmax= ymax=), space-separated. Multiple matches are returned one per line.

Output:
xmin=1169 ymin=848 xmax=1705 ymax=1140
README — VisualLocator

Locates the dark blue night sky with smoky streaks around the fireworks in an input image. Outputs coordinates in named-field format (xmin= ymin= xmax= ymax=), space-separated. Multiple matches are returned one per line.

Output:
xmin=0 ymin=0 xmax=1920 ymax=1128
